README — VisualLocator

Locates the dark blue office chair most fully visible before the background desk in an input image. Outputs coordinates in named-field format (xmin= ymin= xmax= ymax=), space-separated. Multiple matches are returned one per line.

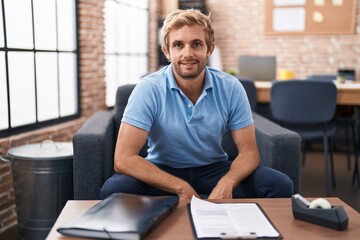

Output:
xmin=270 ymin=80 xmax=337 ymax=196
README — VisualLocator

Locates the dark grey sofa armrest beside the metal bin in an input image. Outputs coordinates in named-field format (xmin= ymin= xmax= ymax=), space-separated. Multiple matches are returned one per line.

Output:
xmin=73 ymin=111 xmax=116 ymax=200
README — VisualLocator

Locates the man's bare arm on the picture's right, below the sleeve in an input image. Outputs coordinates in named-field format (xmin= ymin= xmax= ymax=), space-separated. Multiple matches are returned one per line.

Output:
xmin=209 ymin=124 xmax=260 ymax=199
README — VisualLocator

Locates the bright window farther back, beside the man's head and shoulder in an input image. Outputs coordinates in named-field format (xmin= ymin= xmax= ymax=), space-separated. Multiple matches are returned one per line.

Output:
xmin=105 ymin=0 xmax=149 ymax=107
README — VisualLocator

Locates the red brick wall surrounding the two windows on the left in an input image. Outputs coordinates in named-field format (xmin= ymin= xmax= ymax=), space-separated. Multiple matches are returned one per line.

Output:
xmin=0 ymin=0 xmax=160 ymax=233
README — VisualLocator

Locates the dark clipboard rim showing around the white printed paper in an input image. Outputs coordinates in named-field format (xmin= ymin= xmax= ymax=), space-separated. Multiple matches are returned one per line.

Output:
xmin=186 ymin=202 xmax=283 ymax=240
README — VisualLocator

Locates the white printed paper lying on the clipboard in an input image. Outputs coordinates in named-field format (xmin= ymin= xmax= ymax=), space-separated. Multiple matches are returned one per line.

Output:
xmin=189 ymin=196 xmax=281 ymax=239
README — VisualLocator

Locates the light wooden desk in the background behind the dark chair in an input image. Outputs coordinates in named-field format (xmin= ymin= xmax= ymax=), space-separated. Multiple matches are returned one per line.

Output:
xmin=255 ymin=80 xmax=360 ymax=106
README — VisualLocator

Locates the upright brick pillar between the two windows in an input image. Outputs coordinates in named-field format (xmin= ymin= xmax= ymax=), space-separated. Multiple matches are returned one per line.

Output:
xmin=78 ymin=0 xmax=106 ymax=116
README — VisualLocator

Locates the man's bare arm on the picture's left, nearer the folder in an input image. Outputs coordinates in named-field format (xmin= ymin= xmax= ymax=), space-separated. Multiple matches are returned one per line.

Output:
xmin=114 ymin=123 xmax=198 ymax=199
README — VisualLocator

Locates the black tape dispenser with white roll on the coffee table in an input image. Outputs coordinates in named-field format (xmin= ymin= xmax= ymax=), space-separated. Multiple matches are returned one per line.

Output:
xmin=291 ymin=194 xmax=349 ymax=230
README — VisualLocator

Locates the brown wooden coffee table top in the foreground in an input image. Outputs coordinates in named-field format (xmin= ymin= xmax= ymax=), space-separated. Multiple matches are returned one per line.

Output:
xmin=47 ymin=198 xmax=360 ymax=240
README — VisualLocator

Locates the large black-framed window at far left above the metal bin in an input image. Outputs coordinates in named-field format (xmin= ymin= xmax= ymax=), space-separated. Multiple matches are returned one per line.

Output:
xmin=0 ymin=0 xmax=79 ymax=137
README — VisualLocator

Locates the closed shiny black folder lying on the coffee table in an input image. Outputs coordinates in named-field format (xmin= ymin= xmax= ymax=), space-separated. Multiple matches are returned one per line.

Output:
xmin=57 ymin=193 xmax=179 ymax=239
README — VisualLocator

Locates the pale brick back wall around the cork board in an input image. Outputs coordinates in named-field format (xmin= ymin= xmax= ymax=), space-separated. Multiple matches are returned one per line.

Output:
xmin=206 ymin=0 xmax=360 ymax=79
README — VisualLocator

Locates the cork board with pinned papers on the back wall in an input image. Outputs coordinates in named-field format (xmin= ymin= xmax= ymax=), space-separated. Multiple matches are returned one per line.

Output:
xmin=264 ymin=0 xmax=358 ymax=35
